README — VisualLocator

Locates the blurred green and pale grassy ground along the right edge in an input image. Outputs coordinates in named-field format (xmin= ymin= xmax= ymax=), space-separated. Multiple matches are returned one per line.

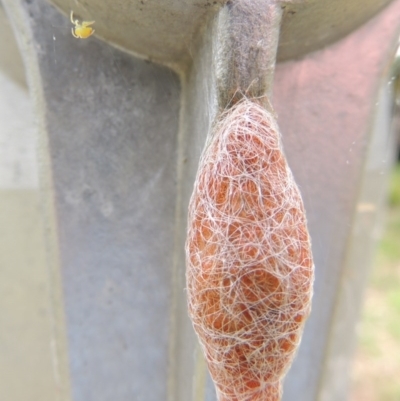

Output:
xmin=350 ymin=162 xmax=400 ymax=401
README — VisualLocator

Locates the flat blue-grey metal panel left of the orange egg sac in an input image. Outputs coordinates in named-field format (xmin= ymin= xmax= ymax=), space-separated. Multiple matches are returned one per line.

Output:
xmin=3 ymin=1 xmax=180 ymax=401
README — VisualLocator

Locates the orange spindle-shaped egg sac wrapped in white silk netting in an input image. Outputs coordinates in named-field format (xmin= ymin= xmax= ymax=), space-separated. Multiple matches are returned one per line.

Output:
xmin=186 ymin=99 xmax=314 ymax=401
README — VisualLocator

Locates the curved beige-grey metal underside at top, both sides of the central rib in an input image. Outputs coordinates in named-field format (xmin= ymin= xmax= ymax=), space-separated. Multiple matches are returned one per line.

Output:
xmin=45 ymin=0 xmax=391 ymax=65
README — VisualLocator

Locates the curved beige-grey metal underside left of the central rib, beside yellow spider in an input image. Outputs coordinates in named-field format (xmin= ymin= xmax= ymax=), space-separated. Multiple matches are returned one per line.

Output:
xmin=48 ymin=0 xmax=226 ymax=65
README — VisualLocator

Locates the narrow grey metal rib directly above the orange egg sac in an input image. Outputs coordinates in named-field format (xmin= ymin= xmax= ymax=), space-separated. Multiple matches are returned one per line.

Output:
xmin=212 ymin=0 xmax=282 ymax=109
